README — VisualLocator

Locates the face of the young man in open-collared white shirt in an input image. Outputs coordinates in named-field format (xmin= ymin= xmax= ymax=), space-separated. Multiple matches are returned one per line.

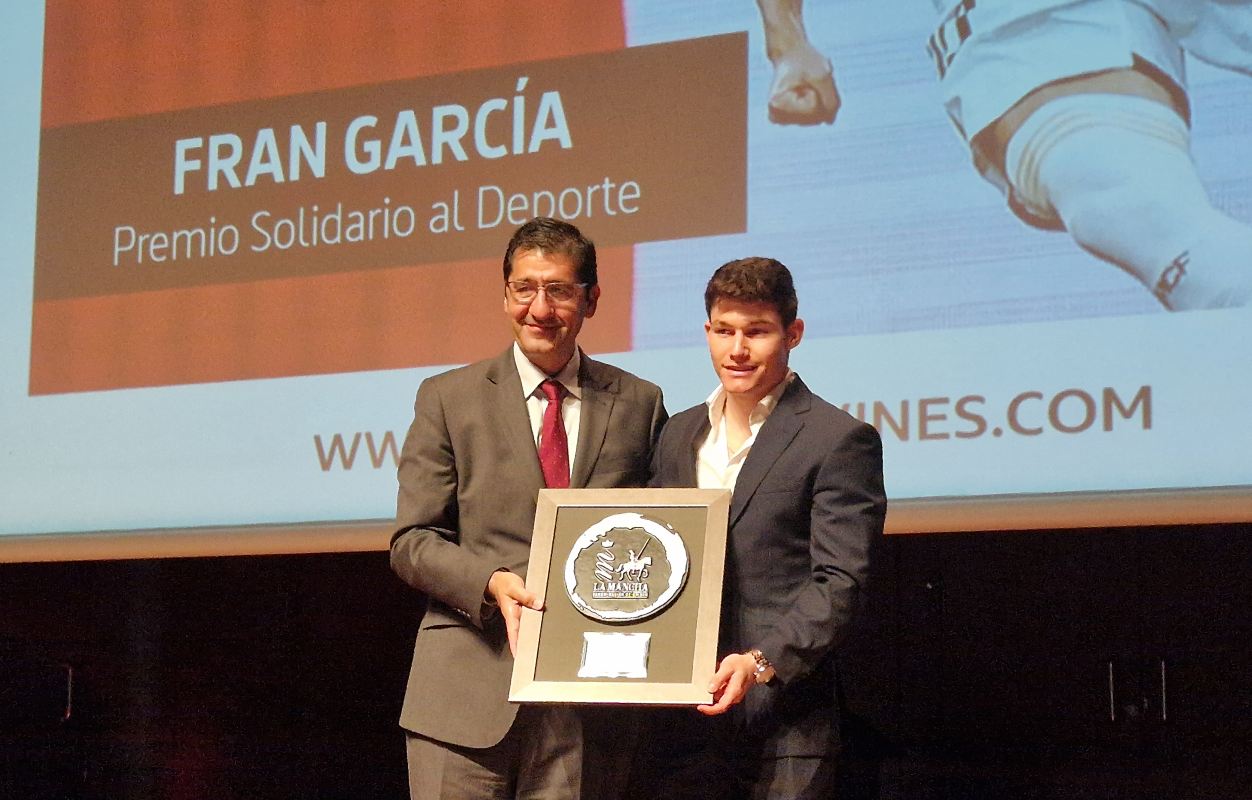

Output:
xmin=705 ymin=298 xmax=804 ymax=408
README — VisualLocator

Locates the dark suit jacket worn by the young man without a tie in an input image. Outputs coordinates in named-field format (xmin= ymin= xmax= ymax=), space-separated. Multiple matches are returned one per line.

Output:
xmin=652 ymin=378 xmax=886 ymax=757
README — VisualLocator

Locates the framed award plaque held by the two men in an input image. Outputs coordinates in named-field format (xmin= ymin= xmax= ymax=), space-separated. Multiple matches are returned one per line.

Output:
xmin=508 ymin=488 xmax=730 ymax=705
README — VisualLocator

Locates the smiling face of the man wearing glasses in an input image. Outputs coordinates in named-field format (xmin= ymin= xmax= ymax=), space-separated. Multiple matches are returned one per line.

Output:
xmin=505 ymin=250 xmax=600 ymax=374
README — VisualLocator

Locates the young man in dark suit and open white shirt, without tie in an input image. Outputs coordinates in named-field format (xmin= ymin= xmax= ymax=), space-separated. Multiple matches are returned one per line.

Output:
xmin=636 ymin=258 xmax=886 ymax=800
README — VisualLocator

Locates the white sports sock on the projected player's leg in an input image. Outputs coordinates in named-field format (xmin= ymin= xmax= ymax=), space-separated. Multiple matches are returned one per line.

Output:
xmin=1005 ymin=94 xmax=1252 ymax=309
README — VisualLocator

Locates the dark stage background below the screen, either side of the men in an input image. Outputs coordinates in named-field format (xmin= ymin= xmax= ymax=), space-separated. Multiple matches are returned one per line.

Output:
xmin=0 ymin=525 xmax=1252 ymax=800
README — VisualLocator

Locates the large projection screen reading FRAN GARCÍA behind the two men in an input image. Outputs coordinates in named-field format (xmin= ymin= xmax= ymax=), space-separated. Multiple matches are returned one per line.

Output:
xmin=0 ymin=0 xmax=1252 ymax=560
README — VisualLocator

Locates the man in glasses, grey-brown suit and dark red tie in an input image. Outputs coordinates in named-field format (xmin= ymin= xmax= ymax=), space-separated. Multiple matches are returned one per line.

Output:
xmin=391 ymin=218 xmax=666 ymax=800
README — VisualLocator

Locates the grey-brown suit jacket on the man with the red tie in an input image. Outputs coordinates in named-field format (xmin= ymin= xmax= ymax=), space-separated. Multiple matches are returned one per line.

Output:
xmin=391 ymin=348 xmax=666 ymax=747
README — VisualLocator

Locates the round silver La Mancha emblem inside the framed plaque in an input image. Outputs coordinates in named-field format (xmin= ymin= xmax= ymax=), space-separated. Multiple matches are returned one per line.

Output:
xmin=565 ymin=512 xmax=690 ymax=622
